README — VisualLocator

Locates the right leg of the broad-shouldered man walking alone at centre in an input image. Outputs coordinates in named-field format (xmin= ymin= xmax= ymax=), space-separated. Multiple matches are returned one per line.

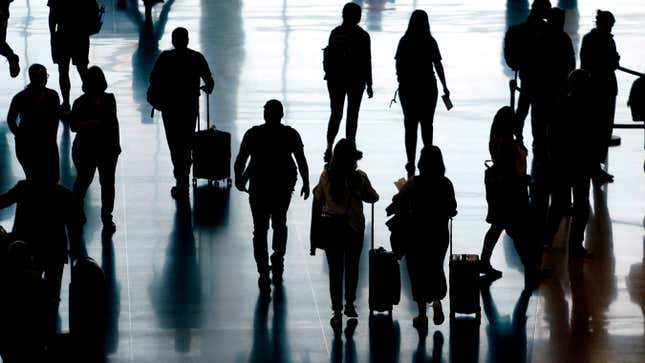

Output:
xmin=270 ymin=193 xmax=291 ymax=283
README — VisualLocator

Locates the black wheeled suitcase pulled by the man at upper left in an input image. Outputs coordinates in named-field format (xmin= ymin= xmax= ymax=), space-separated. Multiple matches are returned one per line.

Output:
xmin=192 ymin=95 xmax=231 ymax=187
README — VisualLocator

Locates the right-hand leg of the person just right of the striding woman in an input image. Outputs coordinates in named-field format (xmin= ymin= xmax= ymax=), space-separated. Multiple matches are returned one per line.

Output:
xmin=569 ymin=176 xmax=591 ymax=257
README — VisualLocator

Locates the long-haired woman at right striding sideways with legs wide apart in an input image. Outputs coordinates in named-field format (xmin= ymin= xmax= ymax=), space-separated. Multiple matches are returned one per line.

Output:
xmin=481 ymin=106 xmax=537 ymax=286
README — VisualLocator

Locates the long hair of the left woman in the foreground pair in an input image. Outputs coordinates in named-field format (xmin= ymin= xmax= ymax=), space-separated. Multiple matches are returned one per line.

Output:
xmin=327 ymin=139 xmax=360 ymax=202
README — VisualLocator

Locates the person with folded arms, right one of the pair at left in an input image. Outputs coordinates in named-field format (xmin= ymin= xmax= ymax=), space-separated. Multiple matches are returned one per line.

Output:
xmin=70 ymin=66 xmax=121 ymax=233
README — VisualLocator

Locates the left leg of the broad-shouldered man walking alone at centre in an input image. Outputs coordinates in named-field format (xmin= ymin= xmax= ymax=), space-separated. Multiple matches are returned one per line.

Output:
xmin=249 ymin=193 xmax=271 ymax=292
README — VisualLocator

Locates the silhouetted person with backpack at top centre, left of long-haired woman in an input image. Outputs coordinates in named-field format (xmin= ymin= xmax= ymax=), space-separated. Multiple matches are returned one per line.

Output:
xmin=323 ymin=3 xmax=374 ymax=162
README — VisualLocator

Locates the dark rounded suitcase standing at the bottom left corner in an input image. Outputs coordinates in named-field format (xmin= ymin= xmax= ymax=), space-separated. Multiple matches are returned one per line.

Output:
xmin=69 ymin=257 xmax=108 ymax=356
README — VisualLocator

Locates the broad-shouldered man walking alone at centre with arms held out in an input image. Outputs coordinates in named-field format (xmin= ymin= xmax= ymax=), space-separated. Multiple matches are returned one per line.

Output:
xmin=234 ymin=100 xmax=309 ymax=294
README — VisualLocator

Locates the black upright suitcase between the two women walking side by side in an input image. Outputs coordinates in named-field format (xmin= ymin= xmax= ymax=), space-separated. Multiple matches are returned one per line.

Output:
xmin=369 ymin=204 xmax=401 ymax=314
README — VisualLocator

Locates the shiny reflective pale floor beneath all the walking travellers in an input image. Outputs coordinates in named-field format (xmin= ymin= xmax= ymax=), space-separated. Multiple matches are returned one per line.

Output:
xmin=0 ymin=0 xmax=645 ymax=363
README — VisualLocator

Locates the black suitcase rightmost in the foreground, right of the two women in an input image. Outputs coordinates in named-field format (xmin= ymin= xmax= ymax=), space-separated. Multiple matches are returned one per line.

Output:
xmin=448 ymin=219 xmax=481 ymax=323
